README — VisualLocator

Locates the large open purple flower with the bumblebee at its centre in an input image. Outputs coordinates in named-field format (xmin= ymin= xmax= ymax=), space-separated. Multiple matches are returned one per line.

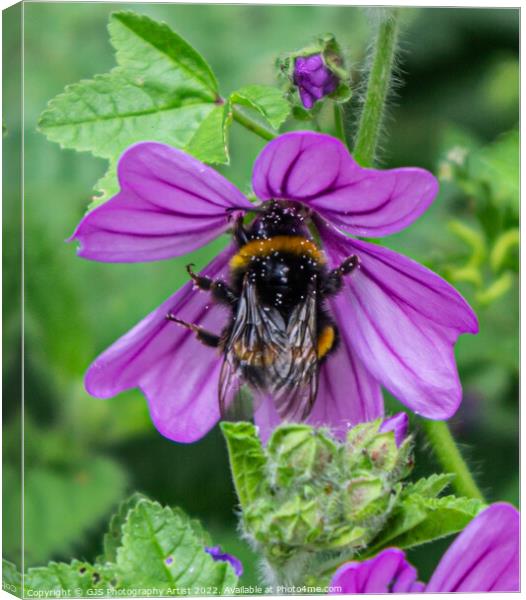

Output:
xmin=71 ymin=132 xmax=477 ymax=442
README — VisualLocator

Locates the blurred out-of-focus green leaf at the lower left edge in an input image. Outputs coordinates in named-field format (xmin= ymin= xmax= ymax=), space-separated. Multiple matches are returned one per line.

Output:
xmin=24 ymin=458 xmax=126 ymax=564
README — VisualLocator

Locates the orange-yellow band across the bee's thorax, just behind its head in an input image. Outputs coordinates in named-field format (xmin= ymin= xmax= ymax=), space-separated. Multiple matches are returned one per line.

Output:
xmin=230 ymin=235 xmax=325 ymax=269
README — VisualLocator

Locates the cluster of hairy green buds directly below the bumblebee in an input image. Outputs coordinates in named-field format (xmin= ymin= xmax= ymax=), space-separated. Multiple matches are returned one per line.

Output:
xmin=223 ymin=419 xmax=412 ymax=572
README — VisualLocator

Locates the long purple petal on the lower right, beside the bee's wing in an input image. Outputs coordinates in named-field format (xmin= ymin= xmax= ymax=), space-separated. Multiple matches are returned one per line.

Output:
xmin=317 ymin=218 xmax=478 ymax=419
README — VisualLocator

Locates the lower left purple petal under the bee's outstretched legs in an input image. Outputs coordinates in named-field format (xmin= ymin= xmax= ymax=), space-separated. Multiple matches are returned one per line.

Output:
xmin=85 ymin=245 xmax=235 ymax=442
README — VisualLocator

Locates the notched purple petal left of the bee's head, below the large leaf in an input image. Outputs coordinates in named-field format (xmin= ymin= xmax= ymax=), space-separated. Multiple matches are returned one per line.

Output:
xmin=70 ymin=142 xmax=252 ymax=262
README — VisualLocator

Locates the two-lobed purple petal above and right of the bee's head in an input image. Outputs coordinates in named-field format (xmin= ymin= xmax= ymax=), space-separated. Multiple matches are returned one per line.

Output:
xmin=252 ymin=131 xmax=438 ymax=237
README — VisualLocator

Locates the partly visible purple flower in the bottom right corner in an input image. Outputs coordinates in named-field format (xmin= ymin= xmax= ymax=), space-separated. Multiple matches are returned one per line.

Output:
xmin=331 ymin=502 xmax=519 ymax=594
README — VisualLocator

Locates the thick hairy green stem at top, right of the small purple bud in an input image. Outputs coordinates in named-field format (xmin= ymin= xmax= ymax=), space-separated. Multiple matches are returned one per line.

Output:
xmin=353 ymin=8 xmax=398 ymax=167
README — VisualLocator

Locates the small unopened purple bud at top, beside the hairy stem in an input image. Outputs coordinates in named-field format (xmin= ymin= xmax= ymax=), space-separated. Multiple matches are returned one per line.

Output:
xmin=293 ymin=54 xmax=338 ymax=109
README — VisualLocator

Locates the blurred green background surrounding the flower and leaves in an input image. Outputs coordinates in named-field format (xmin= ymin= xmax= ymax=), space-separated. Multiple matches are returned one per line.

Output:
xmin=3 ymin=3 xmax=519 ymax=584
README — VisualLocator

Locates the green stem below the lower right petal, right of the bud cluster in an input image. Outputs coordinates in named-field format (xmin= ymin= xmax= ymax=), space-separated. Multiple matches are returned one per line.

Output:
xmin=420 ymin=419 xmax=484 ymax=501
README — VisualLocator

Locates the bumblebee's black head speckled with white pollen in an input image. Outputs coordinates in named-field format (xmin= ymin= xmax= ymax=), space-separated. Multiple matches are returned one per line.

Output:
xmin=248 ymin=200 xmax=310 ymax=240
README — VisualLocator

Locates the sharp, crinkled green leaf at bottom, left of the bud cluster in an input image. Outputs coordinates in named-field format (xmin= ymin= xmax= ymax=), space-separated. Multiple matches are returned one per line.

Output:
xmin=116 ymin=500 xmax=237 ymax=595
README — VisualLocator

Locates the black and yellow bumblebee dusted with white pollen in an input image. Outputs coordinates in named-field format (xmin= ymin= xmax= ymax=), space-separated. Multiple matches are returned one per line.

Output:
xmin=167 ymin=201 xmax=358 ymax=421
